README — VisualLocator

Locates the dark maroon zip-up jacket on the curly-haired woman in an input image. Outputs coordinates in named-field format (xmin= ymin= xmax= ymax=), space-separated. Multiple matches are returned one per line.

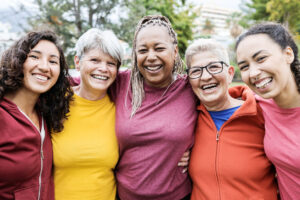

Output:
xmin=0 ymin=98 xmax=54 ymax=200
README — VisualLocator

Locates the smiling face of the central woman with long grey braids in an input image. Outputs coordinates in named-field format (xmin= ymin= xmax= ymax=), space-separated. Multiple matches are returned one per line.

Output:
xmin=135 ymin=25 xmax=178 ymax=88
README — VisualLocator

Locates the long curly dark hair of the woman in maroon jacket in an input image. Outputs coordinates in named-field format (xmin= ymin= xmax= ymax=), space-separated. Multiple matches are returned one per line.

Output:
xmin=0 ymin=31 xmax=73 ymax=132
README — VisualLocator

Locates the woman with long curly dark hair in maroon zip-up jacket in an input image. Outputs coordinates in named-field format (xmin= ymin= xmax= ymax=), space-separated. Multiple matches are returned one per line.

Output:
xmin=0 ymin=31 xmax=73 ymax=200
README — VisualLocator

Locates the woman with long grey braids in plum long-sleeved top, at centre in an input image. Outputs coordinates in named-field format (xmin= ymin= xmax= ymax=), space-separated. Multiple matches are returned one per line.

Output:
xmin=115 ymin=16 xmax=197 ymax=200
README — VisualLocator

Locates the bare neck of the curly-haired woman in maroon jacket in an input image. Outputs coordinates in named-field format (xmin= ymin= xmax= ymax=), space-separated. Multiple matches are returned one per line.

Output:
xmin=5 ymin=89 xmax=40 ymax=116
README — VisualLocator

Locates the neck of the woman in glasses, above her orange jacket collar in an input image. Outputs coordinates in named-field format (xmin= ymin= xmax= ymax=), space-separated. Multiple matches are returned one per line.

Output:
xmin=204 ymin=93 xmax=244 ymax=111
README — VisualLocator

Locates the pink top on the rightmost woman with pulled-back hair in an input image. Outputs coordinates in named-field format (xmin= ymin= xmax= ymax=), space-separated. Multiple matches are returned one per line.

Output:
xmin=255 ymin=95 xmax=300 ymax=200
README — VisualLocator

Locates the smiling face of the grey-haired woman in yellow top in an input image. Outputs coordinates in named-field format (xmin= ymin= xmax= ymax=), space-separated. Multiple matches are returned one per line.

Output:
xmin=75 ymin=48 xmax=118 ymax=98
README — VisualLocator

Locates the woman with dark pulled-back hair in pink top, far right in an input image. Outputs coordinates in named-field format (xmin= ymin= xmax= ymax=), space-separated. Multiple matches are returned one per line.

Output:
xmin=236 ymin=22 xmax=300 ymax=199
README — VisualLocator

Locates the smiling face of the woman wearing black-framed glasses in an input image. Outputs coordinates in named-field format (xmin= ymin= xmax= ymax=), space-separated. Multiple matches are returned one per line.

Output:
xmin=190 ymin=51 xmax=234 ymax=107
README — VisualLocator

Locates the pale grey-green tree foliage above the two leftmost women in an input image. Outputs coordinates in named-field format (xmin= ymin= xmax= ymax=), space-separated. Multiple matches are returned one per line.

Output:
xmin=29 ymin=0 xmax=120 ymax=65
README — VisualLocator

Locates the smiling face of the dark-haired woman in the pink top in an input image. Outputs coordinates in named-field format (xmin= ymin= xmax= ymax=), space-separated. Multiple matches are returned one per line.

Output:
xmin=236 ymin=34 xmax=295 ymax=101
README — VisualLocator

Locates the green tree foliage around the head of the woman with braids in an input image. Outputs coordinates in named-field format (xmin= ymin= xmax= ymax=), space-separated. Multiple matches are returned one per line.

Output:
xmin=113 ymin=0 xmax=196 ymax=56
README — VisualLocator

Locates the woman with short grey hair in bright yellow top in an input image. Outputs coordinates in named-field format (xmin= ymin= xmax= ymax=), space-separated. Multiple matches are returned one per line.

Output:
xmin=52 ymin=28 xmax=123 ymax=200
